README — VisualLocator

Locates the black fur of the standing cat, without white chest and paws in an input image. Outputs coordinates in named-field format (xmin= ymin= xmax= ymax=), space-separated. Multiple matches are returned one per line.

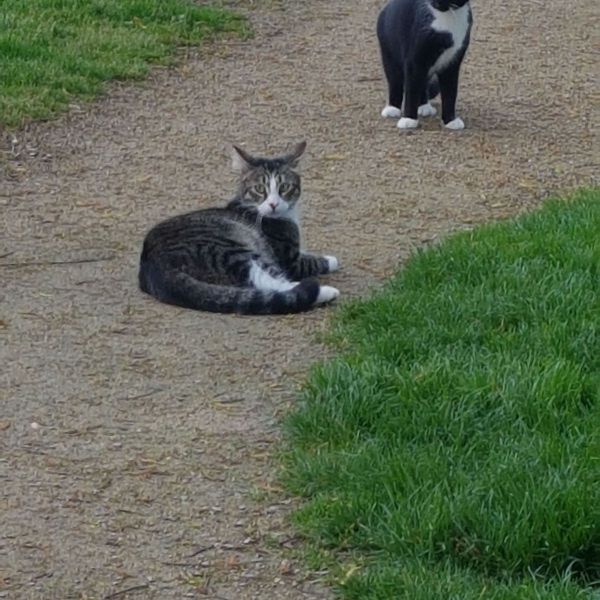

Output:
xmin=377 ymin=0 xmax=473 ymax=124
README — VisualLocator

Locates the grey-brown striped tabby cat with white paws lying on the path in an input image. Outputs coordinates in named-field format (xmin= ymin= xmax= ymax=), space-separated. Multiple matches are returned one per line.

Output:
xmin=139 ymin=142 xmax=339 ymax=314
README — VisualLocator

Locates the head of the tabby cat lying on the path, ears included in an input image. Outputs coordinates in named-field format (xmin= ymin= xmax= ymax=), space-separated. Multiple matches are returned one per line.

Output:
xmin=234 ymin=143 xmax=306 ymax=218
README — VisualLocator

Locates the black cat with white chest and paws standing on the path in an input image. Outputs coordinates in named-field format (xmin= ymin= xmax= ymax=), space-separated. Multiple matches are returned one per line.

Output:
xmin=377 ymin=0 xmax=473 ymax=129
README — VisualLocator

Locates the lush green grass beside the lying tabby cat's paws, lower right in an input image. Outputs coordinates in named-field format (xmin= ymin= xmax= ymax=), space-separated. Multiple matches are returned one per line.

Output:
xmin=284 ymin=189 xmax=600 ymax=600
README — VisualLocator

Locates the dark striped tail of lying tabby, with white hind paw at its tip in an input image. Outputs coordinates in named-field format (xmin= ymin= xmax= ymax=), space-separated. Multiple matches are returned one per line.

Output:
xmin=139 ymin=262 xmax=337 ymax=315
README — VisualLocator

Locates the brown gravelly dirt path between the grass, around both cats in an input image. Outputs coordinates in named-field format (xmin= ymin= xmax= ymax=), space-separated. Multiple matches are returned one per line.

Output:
xmin=0 ymin=0 xmax=599 ymax=600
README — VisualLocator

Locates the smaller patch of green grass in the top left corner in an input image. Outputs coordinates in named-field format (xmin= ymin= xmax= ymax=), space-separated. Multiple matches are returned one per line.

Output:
xmin=0 ymin=0 xmax=245 ymax=127
